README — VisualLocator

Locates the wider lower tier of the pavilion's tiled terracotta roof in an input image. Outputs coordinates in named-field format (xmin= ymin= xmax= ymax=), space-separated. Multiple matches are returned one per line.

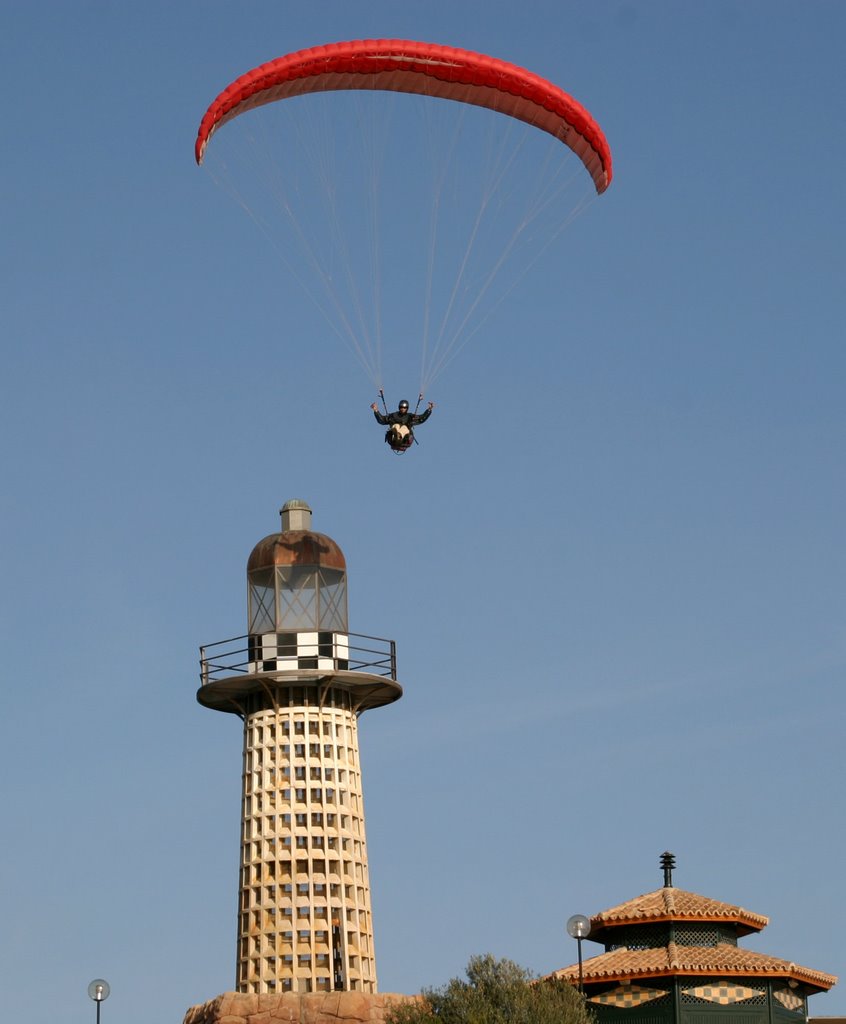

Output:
xmin=549 ymin=942 xmax=837 ymax=990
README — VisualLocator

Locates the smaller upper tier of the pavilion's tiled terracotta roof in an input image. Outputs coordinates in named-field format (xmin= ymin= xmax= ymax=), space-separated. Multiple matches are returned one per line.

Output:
xmin=590 ymin=886 xmax=769 ymax=939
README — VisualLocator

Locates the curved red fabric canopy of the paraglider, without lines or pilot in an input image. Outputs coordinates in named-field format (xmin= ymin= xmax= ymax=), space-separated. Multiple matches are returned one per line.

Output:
xmin=195 ymin=39 xmax=611 ymax=194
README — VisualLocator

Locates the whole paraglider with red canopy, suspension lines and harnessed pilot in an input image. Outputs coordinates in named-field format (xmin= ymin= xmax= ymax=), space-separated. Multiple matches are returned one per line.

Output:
xmin=195 ymin=39 xmax=612 ymax=454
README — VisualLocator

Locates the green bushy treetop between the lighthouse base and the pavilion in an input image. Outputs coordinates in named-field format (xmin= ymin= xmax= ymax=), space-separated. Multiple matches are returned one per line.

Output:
xmin=387 ymin=953 xmax=591 ymax=1024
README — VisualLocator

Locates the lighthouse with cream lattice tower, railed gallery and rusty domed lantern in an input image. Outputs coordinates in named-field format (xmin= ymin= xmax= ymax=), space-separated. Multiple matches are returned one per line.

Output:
xmin=197 ymin=501 xmax=403 ymax=992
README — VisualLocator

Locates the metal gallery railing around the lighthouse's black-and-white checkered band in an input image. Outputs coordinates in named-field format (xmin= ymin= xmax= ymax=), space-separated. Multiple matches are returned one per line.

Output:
xmin=200 ymin=630 xmax=396 ymax=686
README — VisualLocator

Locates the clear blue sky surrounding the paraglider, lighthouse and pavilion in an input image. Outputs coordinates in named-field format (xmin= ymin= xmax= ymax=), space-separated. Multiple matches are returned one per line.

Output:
xmin=0 ymin=0 xmax=846 ymax=1024
